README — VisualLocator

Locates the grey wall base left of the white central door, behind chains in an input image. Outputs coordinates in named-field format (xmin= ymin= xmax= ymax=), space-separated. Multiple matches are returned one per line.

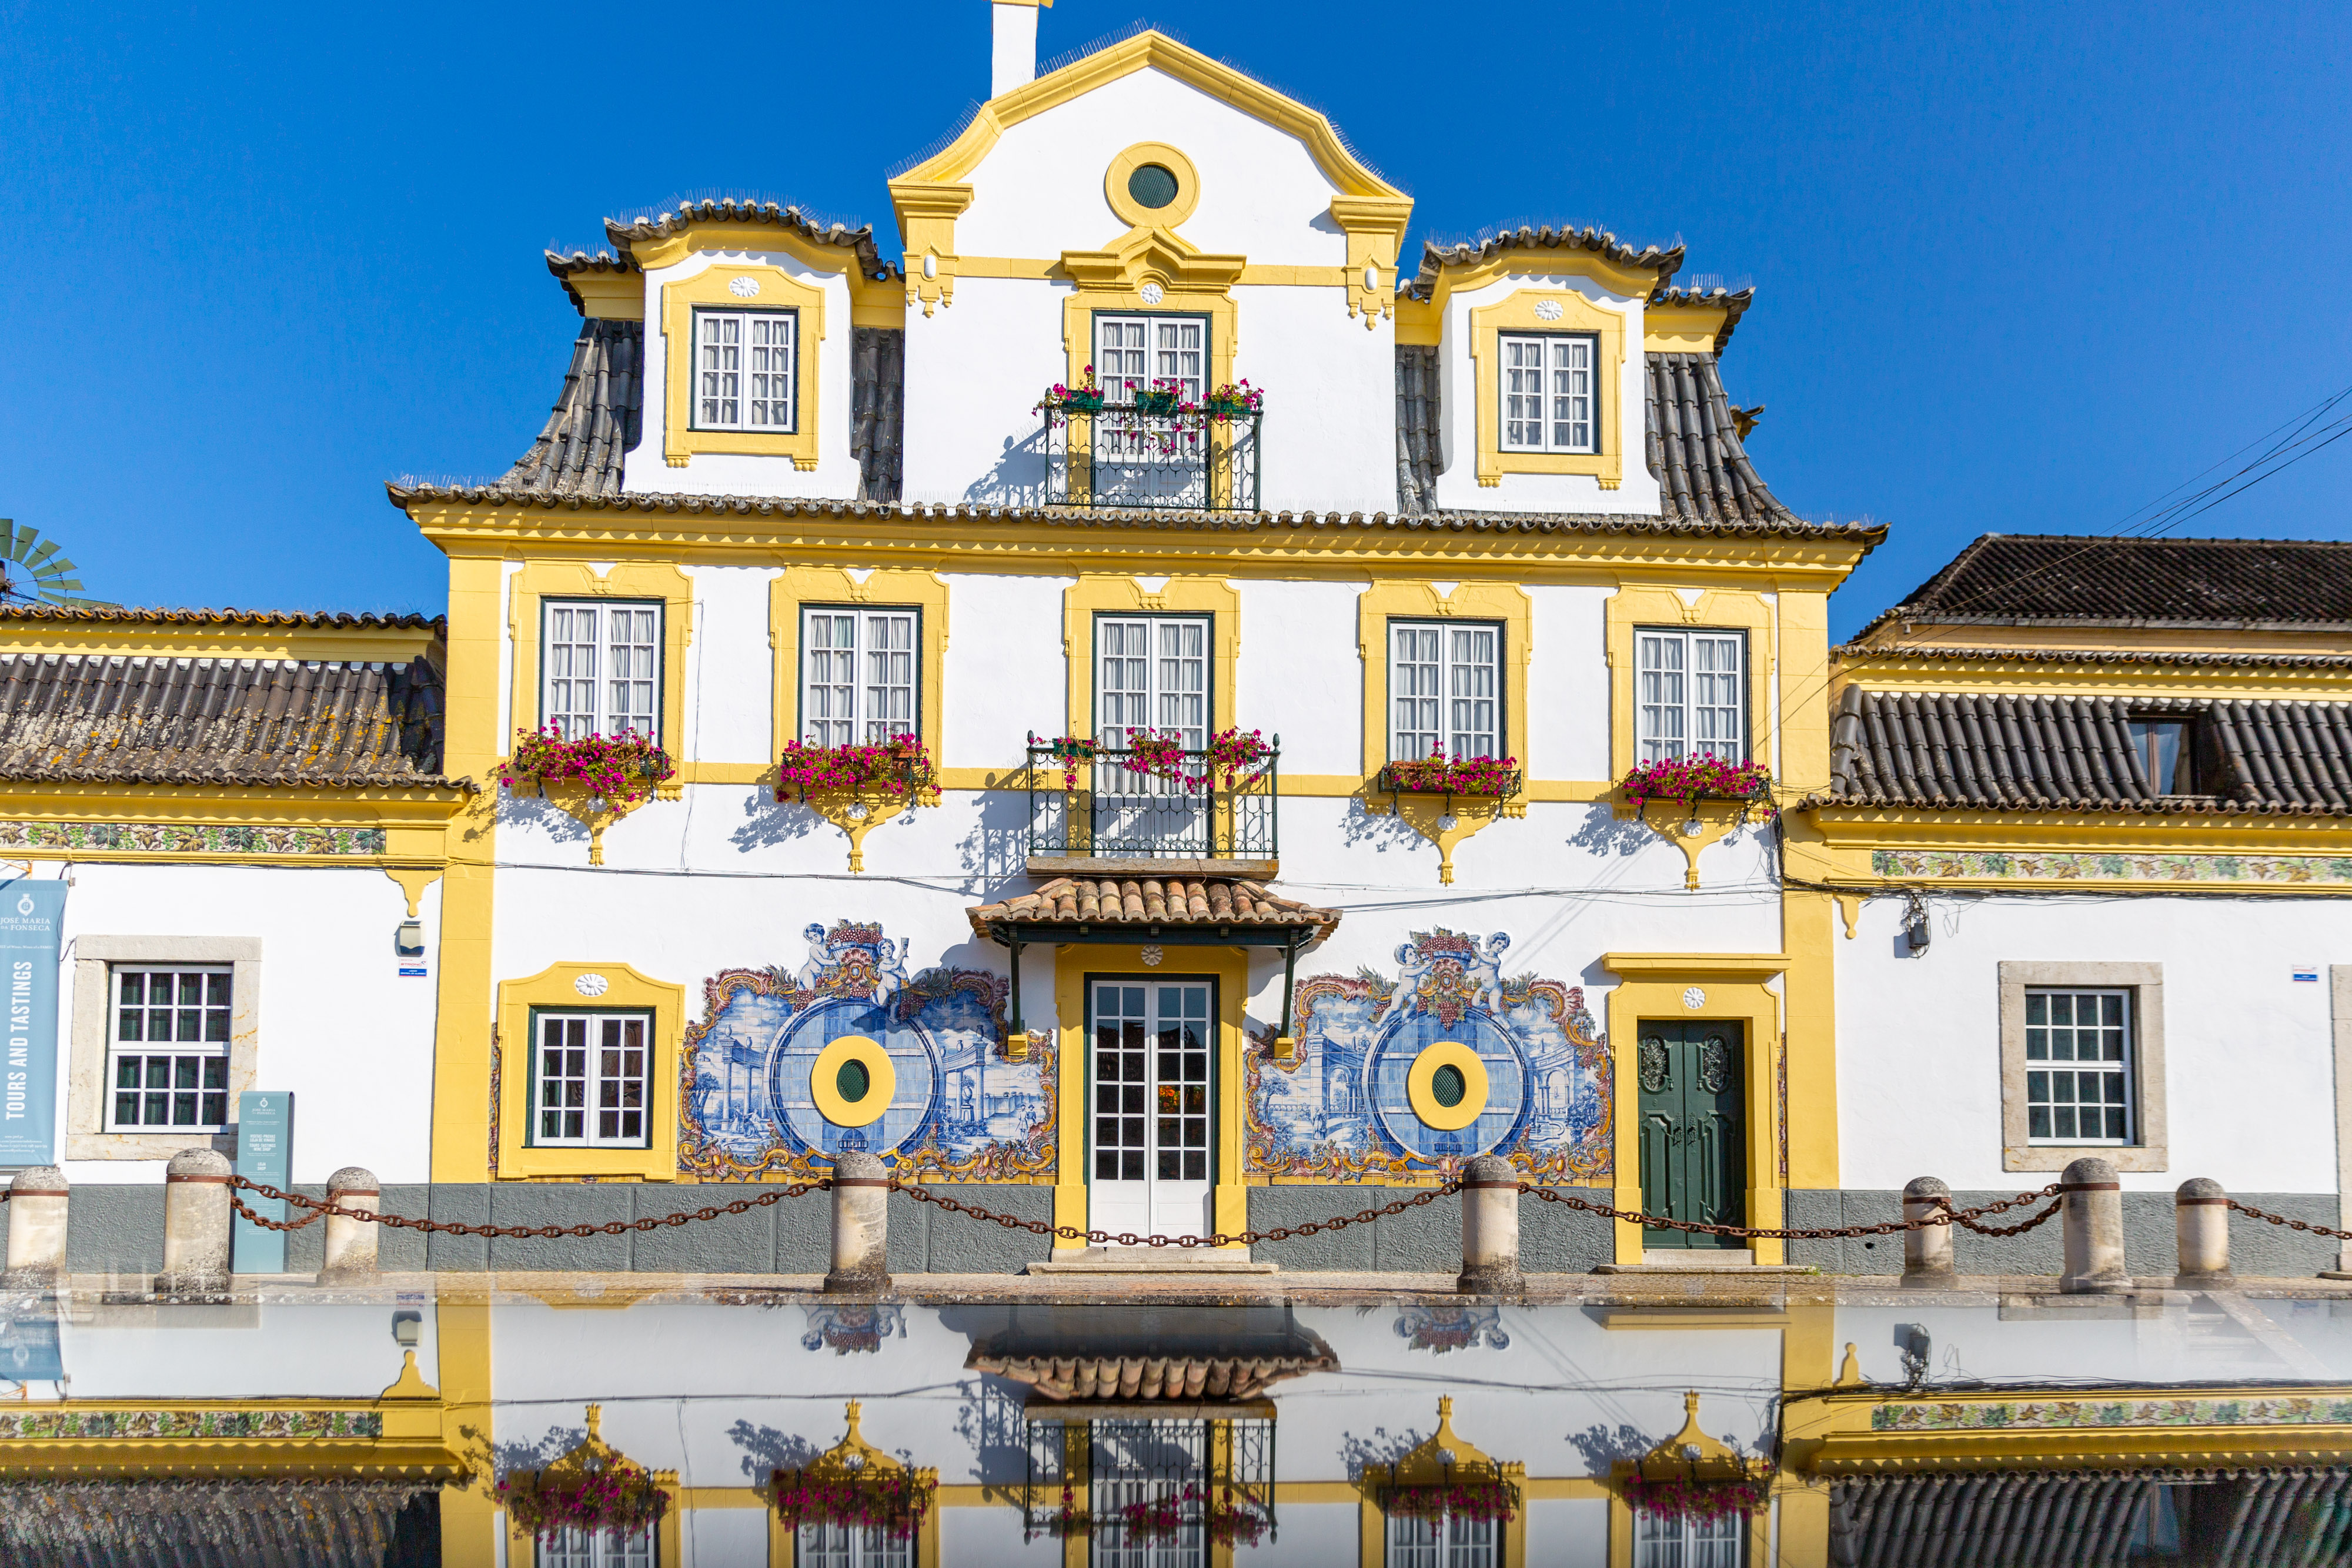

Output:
xmin=21 ymin=1182 xmax=1054 ymax=1274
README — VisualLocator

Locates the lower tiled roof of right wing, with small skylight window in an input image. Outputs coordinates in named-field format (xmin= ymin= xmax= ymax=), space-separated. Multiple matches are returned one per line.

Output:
xmin=1804 ymin=687 xmax=2352 ymax=815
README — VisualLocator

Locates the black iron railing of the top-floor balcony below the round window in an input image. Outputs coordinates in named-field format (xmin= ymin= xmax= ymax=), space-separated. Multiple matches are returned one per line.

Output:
xmin=1044 ymin=402 xmax=1265 ymax=513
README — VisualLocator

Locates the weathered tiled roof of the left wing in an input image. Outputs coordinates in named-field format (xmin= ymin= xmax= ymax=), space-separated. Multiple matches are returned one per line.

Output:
xmin=0 ymin=654 xmax=452 ymax=790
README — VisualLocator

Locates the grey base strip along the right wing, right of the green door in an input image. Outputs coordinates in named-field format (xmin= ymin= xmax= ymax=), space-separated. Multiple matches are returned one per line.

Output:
xmin=1788 ymin=1189 xmax=2338 ymax=1279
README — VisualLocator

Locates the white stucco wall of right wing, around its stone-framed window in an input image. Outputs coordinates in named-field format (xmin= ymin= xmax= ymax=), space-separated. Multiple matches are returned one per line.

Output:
xmin=1832 ymin=893 xmax=2352 ymax=1192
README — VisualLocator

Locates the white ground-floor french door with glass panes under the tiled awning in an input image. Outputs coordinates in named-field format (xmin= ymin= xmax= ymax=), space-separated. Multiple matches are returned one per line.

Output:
xmin=1087 ymin=978 xmax=1216 ymax=1236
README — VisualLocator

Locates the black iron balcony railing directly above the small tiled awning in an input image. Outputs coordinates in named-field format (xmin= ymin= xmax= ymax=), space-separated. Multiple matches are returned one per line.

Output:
xmin=1028 ymin=736 xmax=1282 ymax=860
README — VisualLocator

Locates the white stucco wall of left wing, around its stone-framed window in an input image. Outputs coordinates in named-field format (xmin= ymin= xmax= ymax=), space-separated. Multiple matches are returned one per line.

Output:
xmin=56 ymin=862 xmax=442 ymax=1185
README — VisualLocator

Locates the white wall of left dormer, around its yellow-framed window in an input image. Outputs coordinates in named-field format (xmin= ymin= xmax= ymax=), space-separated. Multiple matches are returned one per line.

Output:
xmin=623 ymin=252 xmax=858 ymax=499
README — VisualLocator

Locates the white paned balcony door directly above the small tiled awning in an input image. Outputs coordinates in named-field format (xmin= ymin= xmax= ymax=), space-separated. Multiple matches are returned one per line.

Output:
xmin=1094 ymin=616 xmax=1211 ymax=855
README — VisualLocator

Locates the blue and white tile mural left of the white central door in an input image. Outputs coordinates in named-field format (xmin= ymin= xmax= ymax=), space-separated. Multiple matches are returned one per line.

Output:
xmin=677 ymin=921 xmax=1054 ymax=1182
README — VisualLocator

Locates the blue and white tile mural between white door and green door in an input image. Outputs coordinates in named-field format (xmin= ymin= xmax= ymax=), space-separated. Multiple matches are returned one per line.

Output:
xmin=1249 ymin=926 xmax=1613 ymax=1185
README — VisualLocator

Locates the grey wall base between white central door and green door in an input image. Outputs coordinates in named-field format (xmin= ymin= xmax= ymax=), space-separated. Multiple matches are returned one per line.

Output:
xmin=1249 ymin=1185 xmax=1613 ymax=1274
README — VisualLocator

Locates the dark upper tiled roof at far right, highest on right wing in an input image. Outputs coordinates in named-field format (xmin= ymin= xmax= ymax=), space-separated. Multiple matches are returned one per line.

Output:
xmin=1863 ymin=534 xmax=2352 ymax=635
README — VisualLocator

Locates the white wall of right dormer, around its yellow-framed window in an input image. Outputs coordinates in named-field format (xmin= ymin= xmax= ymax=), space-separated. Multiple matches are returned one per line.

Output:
xmin=1437 ymin=270 xmax=1658 ymax=515
